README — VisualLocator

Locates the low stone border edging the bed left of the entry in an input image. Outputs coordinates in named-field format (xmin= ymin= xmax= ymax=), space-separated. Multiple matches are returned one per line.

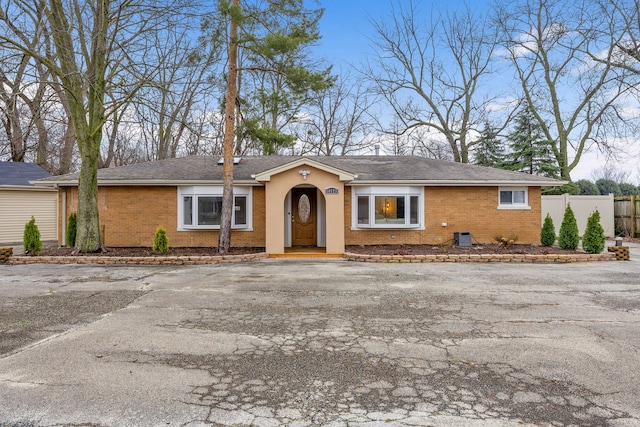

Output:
xmin=9 ymin=252 xmax=267 ymax=265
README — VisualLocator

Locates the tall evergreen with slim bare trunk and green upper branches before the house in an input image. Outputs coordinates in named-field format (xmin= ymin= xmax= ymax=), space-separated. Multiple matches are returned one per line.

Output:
xmin=218 ymin=0 xmax=331 ymax=253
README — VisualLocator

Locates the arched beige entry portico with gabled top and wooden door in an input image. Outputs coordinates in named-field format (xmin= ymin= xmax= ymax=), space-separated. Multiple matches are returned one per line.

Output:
xmin=255 ymin=158 xmax=355 ymax=254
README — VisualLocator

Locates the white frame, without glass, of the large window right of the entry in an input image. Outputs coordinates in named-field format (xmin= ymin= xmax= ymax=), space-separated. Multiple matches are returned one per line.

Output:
xmin=351 ymin=186 xmax=425 ymax=230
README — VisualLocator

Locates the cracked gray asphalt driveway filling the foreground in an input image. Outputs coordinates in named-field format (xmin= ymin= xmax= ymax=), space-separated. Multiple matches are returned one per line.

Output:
xmin=0 ymin=252 xmax=640 ymax=426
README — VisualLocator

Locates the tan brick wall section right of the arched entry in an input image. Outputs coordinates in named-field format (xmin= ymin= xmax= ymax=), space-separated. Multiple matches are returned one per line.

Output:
xmin=344 ymin=187 xmax=542 ymax=245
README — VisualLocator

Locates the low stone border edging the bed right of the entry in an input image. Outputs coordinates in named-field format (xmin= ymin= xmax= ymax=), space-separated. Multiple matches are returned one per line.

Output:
xmin=344 ymin=252 xmax=616 ymax=263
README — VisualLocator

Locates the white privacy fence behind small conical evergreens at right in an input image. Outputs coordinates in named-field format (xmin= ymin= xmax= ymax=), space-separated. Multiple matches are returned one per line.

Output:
xmin=542 ymin=194 xmax=615 ymax=237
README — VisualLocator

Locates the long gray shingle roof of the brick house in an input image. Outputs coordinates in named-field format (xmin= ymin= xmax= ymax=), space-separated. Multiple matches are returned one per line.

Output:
xmin=41 ymin=156 xmax=563 ymax=186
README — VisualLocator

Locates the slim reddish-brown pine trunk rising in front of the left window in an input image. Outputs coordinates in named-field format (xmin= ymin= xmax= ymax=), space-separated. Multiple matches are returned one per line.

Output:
xmin=218 ymin=0 xmax=240 ymax=254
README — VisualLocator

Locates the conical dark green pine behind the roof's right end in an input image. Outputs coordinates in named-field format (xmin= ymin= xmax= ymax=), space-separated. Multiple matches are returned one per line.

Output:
xmin=503 ymin=104 xmax=560 ymax=178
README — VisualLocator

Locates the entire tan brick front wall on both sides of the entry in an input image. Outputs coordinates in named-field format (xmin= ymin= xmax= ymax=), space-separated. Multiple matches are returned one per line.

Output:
xmin=59 ymin=183 xmax=541 ymax=247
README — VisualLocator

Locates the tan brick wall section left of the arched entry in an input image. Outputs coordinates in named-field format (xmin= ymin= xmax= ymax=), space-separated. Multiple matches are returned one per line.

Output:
xmin=60 ymin=187 xmax=265 ymax=247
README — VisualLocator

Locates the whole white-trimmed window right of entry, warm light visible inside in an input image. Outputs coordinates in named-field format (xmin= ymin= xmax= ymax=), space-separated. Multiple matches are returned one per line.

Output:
xmin=352 ymin=186 xmax=424 ymax=228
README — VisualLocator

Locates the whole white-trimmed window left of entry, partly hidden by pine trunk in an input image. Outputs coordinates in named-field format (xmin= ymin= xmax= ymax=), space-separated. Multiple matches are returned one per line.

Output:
xmin=178 ymin=186 xmax=252 ymax=230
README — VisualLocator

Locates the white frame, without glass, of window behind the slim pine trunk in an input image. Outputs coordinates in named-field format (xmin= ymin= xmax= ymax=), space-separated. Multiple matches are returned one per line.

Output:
xmin=178 ymin=185 xmax=253 ymax=231
